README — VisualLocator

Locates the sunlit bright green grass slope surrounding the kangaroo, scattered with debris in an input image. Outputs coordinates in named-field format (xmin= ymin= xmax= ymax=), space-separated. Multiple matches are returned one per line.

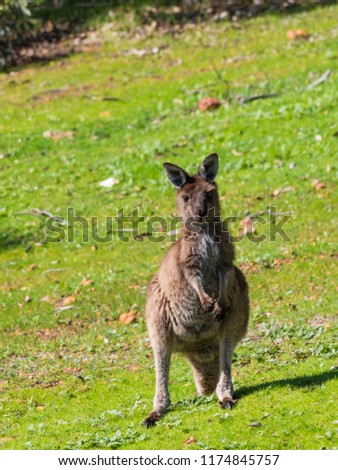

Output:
xmin=0 ymin=6 xmax=338 ymax=449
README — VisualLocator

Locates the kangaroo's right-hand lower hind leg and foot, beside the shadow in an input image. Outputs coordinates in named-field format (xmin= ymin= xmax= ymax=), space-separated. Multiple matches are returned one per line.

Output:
xmin=216 ymin=339 xmax=236 ymax=409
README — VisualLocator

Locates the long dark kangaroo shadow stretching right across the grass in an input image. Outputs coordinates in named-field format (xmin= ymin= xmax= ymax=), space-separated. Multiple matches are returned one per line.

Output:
xmin=235 ymin=370 xmax=338 ymax=398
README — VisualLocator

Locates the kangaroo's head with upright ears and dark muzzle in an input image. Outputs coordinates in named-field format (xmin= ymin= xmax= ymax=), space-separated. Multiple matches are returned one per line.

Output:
xmin=164 ymin=153 xmax=219 ymax=223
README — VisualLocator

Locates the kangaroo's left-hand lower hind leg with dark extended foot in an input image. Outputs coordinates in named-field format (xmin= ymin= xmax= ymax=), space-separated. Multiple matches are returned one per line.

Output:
xmin=143 ymin=344 xmax=171 ymax=428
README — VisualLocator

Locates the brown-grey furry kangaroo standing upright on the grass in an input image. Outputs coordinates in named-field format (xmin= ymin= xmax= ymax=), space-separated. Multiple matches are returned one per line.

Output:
xmin=143 ymin=154 xmax=249 ymax=427
